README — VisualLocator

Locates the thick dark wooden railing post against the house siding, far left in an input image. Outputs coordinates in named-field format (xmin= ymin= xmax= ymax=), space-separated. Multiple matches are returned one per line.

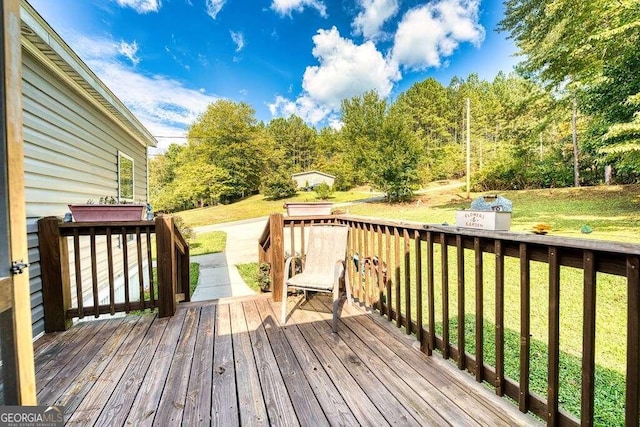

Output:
xmin=38 ymin=216 xmax=72 ymax=332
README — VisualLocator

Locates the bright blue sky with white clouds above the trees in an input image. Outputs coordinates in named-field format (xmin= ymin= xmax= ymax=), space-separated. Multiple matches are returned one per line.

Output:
xmin=28 ymin=0 xmax=517 ymax=151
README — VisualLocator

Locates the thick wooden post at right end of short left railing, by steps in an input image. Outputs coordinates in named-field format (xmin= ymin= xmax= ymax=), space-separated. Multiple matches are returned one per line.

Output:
xmin=155 ymin=215 xmax=176 ymax=317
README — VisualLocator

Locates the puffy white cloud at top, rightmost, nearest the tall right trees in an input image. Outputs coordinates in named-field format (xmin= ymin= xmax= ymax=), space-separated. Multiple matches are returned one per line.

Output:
xmin=392 ymin=0 xmax=485 ymax=70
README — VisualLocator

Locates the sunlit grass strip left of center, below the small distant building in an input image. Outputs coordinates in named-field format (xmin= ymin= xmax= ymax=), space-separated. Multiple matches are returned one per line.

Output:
xmin=176 ymin=190 xmax=380 ymax=227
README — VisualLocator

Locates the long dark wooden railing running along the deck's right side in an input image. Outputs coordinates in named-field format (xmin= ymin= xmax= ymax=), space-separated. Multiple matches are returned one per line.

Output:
xmin=259 ymin=214 xmax=640 ymax=426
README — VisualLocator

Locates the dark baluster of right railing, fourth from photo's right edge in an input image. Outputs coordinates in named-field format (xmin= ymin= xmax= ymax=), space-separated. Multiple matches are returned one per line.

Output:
xmin=518 ymin=243 xmax=531 ymax=412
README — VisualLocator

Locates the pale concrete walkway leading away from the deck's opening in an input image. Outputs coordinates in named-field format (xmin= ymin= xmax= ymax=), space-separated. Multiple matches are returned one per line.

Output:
xmin=191 ymin=217 xmax=267 ymax=301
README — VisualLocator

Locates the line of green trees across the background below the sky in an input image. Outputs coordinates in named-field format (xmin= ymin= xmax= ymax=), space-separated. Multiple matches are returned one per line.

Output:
xmin=150 ymin=0 xmax=640 ymax=211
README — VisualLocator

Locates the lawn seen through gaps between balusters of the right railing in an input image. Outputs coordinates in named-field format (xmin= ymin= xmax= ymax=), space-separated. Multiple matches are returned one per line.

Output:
xmin=352 ymin=239 xmax=627 ymax=425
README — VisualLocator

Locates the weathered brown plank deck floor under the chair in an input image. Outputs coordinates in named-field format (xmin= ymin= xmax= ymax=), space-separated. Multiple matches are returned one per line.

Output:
xmin=35 ymin=297 xmax=537 ymax=426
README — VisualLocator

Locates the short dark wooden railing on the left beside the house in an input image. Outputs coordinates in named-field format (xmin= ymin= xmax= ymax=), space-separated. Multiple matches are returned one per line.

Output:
xmin=38 ymin=215 xmax=190 ymax=332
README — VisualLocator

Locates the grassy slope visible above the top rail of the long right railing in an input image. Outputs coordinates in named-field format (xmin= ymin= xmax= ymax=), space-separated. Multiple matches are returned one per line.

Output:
xmin=348 ymin=185 xmax=640 ymax=243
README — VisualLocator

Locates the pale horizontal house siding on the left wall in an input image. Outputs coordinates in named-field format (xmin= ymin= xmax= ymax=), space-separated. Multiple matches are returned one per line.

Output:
xmin=22 ymin=49 xmax=147 ymax=336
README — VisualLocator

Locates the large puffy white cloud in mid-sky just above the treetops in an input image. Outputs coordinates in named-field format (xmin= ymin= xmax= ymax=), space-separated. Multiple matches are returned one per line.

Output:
xmin=268 ymin=27 xmax=400 ymax=124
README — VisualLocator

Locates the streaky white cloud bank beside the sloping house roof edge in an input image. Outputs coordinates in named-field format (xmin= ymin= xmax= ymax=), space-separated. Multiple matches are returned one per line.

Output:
xmin=65 ymin=34 xmax=219 ymax=152
